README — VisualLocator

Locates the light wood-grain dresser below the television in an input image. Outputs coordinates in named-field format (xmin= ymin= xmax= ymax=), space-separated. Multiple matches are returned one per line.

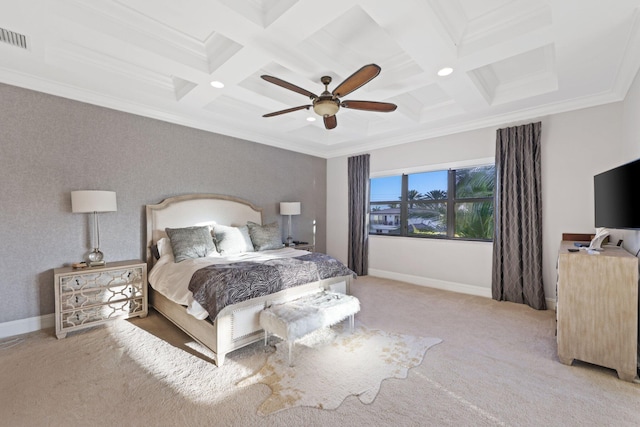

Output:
xmin=556 ymin=241 xmax=638 ymax=381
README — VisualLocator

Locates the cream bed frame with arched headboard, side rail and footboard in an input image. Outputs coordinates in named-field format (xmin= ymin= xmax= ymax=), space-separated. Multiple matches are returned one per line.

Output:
xmin=147 ymin=194 xmax=351 ymax=366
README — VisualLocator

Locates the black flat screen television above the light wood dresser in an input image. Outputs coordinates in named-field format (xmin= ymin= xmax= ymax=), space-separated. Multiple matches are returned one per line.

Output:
xmin=593 ymin=159 xmax=640 ymax=229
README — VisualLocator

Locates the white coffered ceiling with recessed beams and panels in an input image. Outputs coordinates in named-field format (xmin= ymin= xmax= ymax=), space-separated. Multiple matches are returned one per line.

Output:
xmin=0 ymin=0 xmax=640 ymax=158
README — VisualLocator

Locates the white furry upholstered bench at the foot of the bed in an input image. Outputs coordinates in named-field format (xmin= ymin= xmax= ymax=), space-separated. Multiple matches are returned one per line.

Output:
xmin=260 ymin=290 xmax=360 ymax=366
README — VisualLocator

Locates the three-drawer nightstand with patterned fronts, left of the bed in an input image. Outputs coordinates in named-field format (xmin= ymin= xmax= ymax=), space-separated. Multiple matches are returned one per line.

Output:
xmin=53 ymin=260 xmax=148 ymax=338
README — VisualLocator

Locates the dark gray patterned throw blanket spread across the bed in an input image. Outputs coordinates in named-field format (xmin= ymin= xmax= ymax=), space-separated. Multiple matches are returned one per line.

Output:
xmin=189 ymin=252 xmax=356 ymax=319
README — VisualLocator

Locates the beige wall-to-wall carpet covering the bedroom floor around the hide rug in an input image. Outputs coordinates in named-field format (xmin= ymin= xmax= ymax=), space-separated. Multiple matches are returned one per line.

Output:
xmin=0 ymin=277 xmax=640 ymax=427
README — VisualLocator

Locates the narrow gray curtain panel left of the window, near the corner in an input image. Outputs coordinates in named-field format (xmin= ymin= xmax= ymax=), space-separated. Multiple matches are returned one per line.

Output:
xmin=348 ymin=154 xmax=369 ymax=276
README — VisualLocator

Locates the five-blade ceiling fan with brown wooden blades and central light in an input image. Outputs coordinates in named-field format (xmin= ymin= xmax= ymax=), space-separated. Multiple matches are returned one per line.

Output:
xmin=260 ymin=64 xmax=398 ymax=129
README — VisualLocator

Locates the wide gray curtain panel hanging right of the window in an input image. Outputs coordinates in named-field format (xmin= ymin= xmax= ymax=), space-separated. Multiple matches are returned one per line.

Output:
xmin=491 ymin=122 xmax=546 ymax=310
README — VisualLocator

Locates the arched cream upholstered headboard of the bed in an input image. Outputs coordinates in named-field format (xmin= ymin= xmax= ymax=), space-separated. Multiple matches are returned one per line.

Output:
xmin=147 ymin=194 xmax=262 ymax=268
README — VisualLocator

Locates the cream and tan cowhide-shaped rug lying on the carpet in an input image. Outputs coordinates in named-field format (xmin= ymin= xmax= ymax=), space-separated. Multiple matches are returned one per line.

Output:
xmin=238 ymin=322 xmax=441 ymax=415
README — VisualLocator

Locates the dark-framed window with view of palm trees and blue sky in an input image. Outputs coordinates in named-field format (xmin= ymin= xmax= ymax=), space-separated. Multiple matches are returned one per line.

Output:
xmin=369 ymin=165 xmax=495 ymax=240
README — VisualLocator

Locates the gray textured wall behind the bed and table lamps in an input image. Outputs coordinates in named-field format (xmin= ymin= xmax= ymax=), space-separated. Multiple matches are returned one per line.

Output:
xmin=0 ymin=84 xmax=326 ymax=323
